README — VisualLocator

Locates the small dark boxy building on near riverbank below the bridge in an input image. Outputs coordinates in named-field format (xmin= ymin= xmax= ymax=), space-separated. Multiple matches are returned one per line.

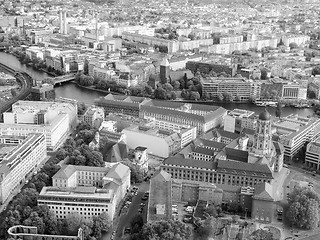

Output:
xmin=30 ymin=83 xmax=56 ymax=101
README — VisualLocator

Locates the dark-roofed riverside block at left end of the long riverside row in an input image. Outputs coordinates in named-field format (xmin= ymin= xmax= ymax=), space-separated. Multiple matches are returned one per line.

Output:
xmin=94 ymin=93 xmax=148 ymax=116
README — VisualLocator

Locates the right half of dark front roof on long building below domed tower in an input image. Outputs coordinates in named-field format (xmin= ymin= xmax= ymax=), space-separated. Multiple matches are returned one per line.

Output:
xmin=217 ymin=160 xmax=273 ymax=178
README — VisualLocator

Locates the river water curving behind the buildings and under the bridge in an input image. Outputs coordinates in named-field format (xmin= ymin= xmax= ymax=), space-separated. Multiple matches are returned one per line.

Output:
xmin=0 ymin=52 xmax=313 ymax=117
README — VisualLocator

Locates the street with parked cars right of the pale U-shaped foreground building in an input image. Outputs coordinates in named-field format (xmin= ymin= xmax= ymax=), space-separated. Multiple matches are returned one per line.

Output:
xmin=115 ymin=182 xmax=150 ymax=240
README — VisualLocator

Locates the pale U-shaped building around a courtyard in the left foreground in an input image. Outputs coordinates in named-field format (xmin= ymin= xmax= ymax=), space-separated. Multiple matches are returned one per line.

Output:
xmin=38 ymin=163 xmax=130 ymax=221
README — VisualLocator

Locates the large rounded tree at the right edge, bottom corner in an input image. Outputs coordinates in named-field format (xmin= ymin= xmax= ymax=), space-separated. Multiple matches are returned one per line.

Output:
xmin=287 ymin=187 xmax=320 ymax=229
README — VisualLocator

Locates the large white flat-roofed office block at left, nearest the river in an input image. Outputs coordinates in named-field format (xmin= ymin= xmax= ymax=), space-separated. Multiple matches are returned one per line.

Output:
xmin=0 ymin=101 xmax=77 ymax=150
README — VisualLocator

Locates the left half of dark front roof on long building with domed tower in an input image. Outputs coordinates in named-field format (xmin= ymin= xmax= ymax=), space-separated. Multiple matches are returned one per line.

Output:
xmin=162 ymin=157 xmax=216 ymax=170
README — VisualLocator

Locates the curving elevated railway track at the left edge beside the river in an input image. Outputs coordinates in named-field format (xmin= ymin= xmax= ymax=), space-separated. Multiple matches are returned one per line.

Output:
xmin=0 ymin=63 xmax=32 ymax=114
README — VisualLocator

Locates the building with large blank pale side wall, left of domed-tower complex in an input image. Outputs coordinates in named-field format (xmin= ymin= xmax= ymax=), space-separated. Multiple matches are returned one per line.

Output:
xmin=122 ymin=125 xmax=181 ymax=158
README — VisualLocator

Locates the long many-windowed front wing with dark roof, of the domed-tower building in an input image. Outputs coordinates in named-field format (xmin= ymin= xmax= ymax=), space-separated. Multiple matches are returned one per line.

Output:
xmin=161 ymin=157 xmax=273 ymax=189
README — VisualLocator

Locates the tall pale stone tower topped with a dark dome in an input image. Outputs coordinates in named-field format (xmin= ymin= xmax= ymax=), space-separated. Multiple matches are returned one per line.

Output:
xmin=252 ymin=109 xmax=272 ymax=157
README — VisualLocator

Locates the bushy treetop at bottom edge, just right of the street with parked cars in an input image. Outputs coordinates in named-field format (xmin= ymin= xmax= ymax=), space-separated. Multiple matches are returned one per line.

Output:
xmin=141 ymin=220 xmax=191 ymax=240
